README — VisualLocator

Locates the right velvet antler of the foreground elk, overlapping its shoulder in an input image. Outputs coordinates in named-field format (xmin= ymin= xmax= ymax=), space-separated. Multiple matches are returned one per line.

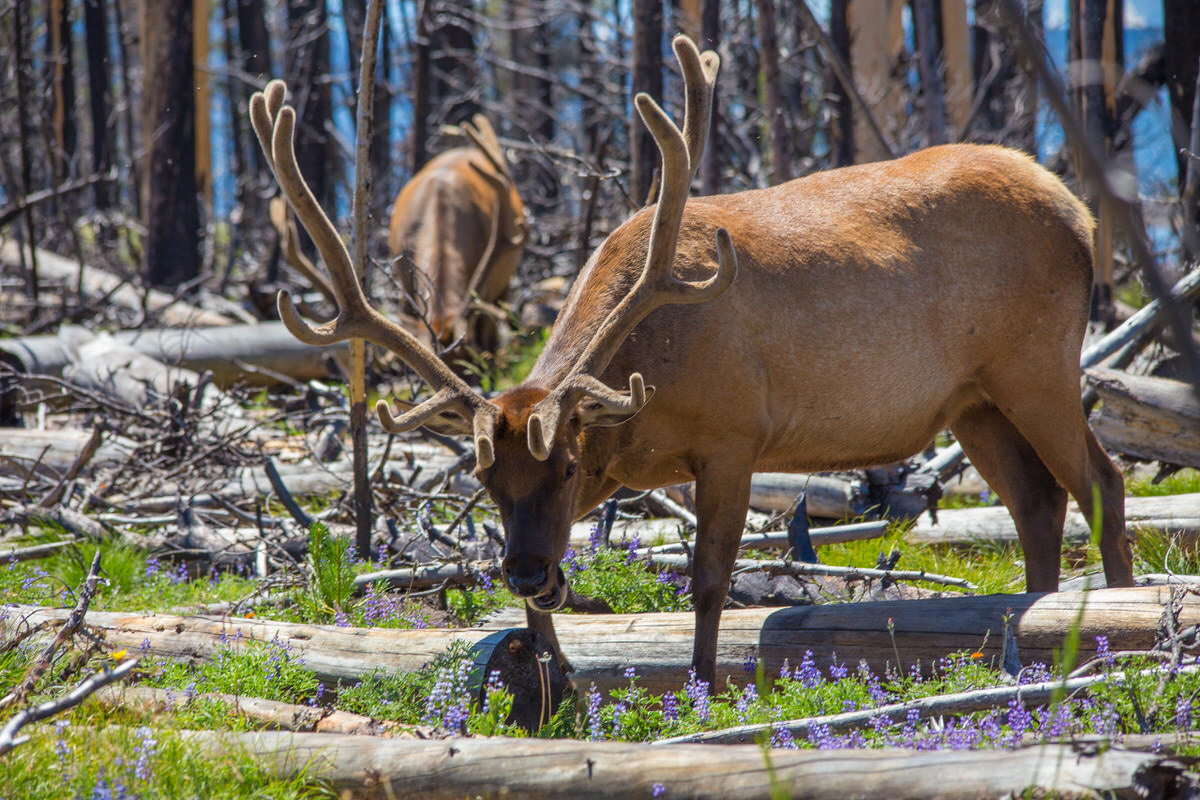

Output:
xmin=528 ymin=35 xmax=738 ymax=461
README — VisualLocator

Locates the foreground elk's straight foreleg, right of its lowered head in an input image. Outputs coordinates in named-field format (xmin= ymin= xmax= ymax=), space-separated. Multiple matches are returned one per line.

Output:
xmin=691 ymin=456 xmax=751 ymax=691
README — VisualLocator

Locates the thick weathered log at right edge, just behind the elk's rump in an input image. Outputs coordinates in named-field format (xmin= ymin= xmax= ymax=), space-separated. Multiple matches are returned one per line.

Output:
xmin=1086 ymin=369 xmax=1200 ymax=467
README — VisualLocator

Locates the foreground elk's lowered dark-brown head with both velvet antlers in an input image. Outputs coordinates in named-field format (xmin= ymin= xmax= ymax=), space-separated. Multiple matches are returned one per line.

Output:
xmin=251 ymin=36 xmax=737 ymax=612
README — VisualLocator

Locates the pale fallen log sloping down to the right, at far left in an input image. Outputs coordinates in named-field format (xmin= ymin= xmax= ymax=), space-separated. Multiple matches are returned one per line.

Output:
xmin=0 ymin=240 xmax=233 ymax=326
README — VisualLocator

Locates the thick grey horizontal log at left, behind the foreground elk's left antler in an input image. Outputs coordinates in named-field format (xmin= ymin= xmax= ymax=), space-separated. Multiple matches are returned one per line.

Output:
xmin=0 ymin=321 xmax=349 ymax=386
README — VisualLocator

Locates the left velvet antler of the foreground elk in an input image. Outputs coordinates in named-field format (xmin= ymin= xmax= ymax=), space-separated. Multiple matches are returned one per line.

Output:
xmin=250 ymin=80 xmax=499 ymax=468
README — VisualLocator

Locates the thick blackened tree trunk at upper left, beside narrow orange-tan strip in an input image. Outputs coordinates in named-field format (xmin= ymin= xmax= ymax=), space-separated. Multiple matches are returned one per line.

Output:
xmin=140 ymin=0 xmax=200 ymax=288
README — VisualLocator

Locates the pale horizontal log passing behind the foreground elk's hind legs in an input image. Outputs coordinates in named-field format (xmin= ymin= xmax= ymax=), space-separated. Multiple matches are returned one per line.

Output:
xmin=905 ymin=493 xmax=1200 ymax=545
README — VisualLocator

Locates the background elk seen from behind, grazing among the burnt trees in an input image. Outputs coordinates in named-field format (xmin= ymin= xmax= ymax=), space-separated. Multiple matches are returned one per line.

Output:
xmin=388 ymin=114 xmax=528 ymax=350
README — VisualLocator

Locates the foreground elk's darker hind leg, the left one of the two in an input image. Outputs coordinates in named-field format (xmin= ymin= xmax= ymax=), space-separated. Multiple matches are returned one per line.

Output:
xmin=950 ymin=403 xmax=1067 ymax=591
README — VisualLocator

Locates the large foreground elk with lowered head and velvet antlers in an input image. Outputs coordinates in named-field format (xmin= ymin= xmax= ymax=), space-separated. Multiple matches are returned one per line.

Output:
xmin=251 ymin=36 xmax=1132 ymax=681
